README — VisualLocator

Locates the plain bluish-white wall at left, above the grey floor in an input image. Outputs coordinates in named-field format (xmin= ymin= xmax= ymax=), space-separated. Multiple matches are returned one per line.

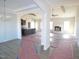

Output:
xmin=0 ymin=15 xmax=20 ymax=43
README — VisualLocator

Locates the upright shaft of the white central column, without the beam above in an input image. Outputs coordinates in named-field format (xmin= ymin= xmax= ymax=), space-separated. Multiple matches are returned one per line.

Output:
xmin=41 ymin=13 xmax=50 ymax=50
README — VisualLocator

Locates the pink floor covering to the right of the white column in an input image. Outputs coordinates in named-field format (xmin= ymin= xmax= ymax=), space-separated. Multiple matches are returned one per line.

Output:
xmin=49 ymin=39 xmax=74 ymax=59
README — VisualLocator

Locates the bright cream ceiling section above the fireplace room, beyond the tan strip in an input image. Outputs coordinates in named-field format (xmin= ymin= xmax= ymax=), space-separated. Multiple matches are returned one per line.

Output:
xmin=51 ymin=6 xmax=77 ymax=17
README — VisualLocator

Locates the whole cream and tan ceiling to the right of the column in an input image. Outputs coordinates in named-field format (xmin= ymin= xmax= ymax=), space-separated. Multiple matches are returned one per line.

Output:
xmin=44 ymin=0 xmax=79 ymax=17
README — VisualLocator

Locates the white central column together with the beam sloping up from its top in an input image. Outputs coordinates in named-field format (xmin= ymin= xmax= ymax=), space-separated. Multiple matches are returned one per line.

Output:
xmin=33 ymin=0 xmax=50 ymax=50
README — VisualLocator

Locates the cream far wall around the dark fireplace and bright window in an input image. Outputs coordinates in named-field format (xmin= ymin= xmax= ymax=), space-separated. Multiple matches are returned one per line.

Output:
xmin=52 ymin=17 xmax=75 ymax=34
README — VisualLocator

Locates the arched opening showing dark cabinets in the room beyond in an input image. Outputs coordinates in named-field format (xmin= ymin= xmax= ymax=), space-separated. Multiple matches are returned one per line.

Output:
xmin=21 ymin=13 xmax=41 ymax=36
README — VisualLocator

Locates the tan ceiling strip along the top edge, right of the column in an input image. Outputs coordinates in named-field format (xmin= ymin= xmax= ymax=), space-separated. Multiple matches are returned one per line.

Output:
xmin=45 ymin=0 xmax=79 ymax=5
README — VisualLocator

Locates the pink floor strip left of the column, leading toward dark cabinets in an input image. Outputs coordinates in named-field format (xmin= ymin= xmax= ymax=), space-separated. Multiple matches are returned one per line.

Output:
xmin=19 ymin=36 xmax=40 ymax=59
